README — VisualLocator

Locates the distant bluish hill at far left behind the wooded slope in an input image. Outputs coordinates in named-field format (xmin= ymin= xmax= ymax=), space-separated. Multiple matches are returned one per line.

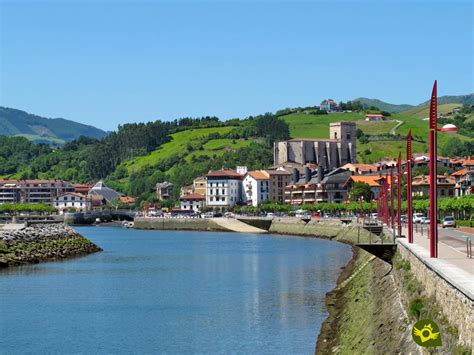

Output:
xmin=0 ymin=107 xmax=107 ymax=145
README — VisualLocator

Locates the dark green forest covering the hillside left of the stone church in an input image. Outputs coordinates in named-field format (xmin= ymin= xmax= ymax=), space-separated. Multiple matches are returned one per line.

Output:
xmin=0 ymin=113 xmax=289 ymax=202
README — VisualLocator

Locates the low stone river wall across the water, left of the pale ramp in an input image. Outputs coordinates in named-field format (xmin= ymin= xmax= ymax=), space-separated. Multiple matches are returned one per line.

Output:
xmin=134 ymin=218 xmax=228 ymax=231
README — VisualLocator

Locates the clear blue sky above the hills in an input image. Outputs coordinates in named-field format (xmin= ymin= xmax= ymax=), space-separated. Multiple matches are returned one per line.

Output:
xmin=0 ymin=0 xmax=474 ymax=130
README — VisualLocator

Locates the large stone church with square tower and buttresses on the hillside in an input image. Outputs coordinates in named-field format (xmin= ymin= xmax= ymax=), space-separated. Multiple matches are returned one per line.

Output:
xmin=274 ymin=122 xmax=357 ymax=171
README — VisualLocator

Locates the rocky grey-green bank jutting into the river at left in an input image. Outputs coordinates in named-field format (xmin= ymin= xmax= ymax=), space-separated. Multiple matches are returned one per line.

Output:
xmin=0 ymin=223 xmax=102 ymax=267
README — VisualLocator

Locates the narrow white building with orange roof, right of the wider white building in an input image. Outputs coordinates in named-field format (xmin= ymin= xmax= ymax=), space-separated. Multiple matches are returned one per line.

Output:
xmin=242 ymin=170 xmax=270 ymax=207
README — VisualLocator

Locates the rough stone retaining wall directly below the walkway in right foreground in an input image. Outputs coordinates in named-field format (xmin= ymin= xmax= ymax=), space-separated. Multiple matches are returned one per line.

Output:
xmin=398 ymin=244 xmax=474 ymax=347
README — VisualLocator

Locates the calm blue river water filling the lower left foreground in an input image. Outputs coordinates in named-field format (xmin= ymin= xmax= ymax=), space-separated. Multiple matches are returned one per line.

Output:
xmin=0 ymin=227 xmax=351 ymax=354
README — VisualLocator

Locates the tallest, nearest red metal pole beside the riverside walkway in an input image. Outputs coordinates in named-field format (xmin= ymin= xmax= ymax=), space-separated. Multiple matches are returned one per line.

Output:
xmin=430 ymin=80 xmax=438 ymax=258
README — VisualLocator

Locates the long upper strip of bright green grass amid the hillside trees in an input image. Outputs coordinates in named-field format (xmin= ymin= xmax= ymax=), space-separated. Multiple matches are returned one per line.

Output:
xmin=123 ymin=127 xmax=235 ymax=172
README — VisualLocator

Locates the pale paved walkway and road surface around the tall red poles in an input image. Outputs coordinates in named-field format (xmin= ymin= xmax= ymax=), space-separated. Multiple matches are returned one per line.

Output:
xmin=397 ymin=228 xmax=474 ymax=299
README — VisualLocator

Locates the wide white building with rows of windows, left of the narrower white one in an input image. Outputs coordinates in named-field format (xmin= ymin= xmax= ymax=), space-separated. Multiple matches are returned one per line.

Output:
xmin=206 ymin=169 xmax=243 ymax=210
